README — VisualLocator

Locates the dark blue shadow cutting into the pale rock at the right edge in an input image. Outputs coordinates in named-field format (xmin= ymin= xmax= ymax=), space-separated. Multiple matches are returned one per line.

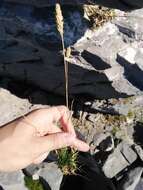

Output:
xmin=117 ymin=55 xmax=143 ymax=91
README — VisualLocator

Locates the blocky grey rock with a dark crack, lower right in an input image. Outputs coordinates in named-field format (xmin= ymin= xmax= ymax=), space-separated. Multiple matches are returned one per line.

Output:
xmin=102 ymin=142 xmax=137 ymax=178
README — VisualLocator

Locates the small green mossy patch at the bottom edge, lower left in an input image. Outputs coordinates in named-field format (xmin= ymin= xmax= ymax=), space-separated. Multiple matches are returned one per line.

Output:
xmin=24 ymin=176 xmax=44 ymax=190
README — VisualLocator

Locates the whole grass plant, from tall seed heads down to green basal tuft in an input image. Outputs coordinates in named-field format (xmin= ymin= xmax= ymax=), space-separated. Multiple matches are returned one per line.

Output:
xmin=55 ymin=3 xmax=78 ymax=175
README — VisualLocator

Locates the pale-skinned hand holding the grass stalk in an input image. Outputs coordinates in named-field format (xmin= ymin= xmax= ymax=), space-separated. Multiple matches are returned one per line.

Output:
xmin=0 ymin=106 xmax=89 ymax=172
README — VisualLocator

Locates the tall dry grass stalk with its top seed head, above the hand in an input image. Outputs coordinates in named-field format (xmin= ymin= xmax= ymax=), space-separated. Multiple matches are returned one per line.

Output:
xmin=55 ymin=3 xmax=69 ymax=108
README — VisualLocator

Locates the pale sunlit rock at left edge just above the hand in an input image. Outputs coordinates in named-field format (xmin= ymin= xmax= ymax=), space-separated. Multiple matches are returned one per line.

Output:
xmin=0 ymin=87 xmax=50 ymax=126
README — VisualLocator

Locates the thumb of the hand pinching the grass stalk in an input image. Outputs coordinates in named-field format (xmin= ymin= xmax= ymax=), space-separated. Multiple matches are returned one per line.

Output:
xmin=38 ymin=132 xmax=89 ymax=152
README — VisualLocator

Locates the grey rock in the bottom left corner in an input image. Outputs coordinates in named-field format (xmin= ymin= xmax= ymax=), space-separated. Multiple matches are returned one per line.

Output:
xmin=0 ymin=171 xmax=28 ymax=190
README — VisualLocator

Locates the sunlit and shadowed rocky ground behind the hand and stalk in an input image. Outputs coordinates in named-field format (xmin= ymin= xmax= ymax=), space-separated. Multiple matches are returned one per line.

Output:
xmin=0 ymin=0 xmax=143 ymax=190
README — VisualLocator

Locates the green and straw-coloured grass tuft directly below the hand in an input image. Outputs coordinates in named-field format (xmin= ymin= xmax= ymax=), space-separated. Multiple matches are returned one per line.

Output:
xmin=57 ymin=148 xmax=78 ymax=176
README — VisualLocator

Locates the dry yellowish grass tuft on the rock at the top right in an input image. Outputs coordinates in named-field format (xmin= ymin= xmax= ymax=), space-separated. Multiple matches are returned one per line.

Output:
xmin=84 ymin=5 xmax=116 ymax=29
